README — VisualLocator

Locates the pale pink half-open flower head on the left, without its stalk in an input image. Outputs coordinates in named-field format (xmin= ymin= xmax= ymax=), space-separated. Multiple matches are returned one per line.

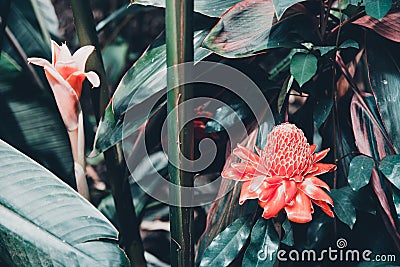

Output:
xmin=28 ymin=40 xmax=100 ymax=131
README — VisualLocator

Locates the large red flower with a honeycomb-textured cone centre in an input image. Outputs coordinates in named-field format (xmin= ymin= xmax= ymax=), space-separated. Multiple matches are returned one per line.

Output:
xmin=222 ymin=123 xmax=336 ymax=223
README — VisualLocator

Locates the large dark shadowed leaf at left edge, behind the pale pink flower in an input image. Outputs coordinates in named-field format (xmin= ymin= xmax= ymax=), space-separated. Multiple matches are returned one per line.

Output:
xmin=0 ymin=51 xmax=75 ymax=187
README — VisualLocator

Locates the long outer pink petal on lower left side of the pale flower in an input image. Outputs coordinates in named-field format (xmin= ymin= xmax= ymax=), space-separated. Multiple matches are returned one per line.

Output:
xmin=44 ymin=66 xmax=81 ymax=131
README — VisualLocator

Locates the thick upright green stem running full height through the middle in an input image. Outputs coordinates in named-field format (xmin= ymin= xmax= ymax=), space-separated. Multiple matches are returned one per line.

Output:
xmin=165 ymin=0 xmax=194 ymax=267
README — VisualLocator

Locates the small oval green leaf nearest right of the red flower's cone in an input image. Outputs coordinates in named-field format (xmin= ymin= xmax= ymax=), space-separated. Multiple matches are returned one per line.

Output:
xmin=347 ymin=155 xmax=375 ymax=191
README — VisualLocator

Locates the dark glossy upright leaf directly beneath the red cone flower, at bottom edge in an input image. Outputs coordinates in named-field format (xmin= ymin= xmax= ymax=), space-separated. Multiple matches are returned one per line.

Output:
xmin=242 ymin=217 xmax=279 ymax=267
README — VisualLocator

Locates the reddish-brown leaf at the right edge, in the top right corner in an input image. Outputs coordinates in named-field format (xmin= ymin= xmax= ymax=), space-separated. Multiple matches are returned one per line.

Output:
xmin=353 ymin=10 xmax=400 ymax=42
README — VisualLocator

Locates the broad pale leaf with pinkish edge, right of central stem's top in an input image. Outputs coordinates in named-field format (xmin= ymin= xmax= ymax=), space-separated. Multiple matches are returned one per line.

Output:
xmin=203 ymin=0 xmax=312 ymax=58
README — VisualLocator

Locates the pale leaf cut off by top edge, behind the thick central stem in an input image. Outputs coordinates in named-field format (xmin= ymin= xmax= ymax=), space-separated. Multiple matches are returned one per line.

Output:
xmin=131 ymin=0 xmax=242 ymax=18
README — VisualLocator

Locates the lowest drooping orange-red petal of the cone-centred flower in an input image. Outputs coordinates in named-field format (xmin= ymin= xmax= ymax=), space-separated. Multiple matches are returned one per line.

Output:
xmin=285 ymin=191 xmax=313 ymax=223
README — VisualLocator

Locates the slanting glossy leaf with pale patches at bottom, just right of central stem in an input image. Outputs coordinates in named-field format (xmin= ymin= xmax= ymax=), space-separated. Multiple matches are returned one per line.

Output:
xmin=200 ymin=216 xmax=252 ymax=266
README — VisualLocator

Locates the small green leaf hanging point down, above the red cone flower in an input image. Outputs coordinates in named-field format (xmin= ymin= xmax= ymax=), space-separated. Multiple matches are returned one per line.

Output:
xmin=290 ymin=52 xmax=318 ymax=86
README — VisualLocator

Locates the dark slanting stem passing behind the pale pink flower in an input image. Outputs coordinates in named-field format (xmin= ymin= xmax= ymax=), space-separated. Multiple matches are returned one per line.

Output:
xmin=71 ymin=0 xmax=146 ymax=267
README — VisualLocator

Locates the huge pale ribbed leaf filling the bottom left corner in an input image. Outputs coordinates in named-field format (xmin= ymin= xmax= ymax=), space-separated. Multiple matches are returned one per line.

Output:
xmin=0 ymin=141 xmax=129 ymax=266
